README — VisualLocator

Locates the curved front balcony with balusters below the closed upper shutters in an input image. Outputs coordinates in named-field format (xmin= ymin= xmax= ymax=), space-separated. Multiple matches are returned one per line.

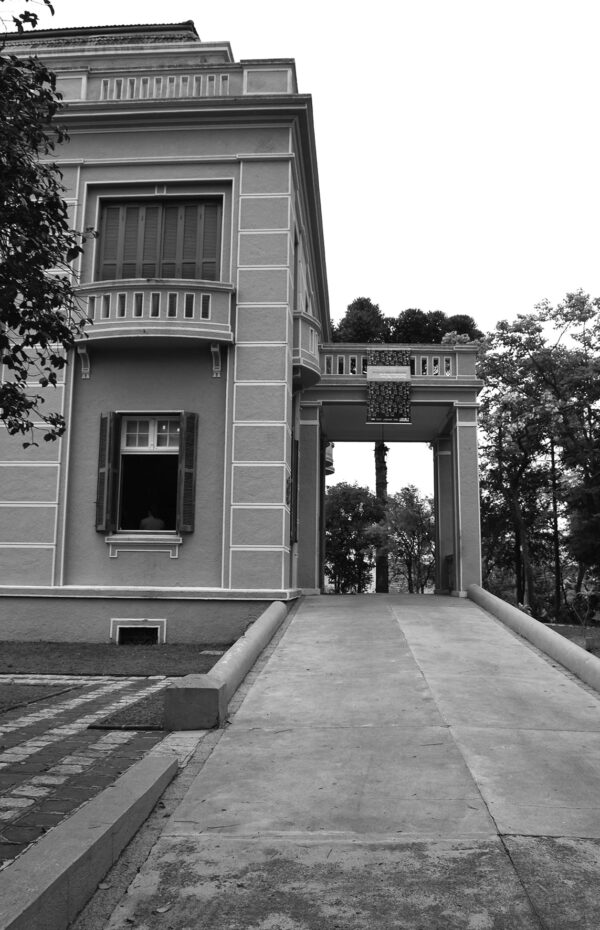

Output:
xmin=77 ymin=278 xmax=234 ymax=343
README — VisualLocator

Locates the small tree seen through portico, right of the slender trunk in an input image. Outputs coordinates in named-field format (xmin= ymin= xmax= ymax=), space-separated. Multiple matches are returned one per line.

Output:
xmin=386 ymin=485 xmax=435 ymax=594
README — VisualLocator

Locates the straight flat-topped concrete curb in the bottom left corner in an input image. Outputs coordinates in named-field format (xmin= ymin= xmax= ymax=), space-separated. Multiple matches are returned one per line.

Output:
xmin=0 ymin=753 xmax=178 ymax=930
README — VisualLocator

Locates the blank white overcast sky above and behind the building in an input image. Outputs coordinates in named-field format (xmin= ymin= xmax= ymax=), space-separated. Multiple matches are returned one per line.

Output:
xmin=12 ymin=0 xmax=600 ymax=490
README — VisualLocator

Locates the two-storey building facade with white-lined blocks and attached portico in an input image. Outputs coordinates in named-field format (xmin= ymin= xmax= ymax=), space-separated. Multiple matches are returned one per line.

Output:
xmin=0 ymin=22 xmax=479 ymax=642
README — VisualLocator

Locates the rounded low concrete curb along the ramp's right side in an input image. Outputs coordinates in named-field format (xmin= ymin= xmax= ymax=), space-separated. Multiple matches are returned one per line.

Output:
xmin=468 ymin=584 xmax=600 ymax=691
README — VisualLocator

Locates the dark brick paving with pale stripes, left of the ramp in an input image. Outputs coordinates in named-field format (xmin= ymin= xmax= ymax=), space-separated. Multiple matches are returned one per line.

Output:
xmin=0 ymin=675 xmax=173 ymax=869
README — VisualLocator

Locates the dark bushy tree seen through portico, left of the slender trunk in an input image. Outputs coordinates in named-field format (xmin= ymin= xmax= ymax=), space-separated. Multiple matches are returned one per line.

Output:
xmin=325 ymin=482 xmax=383 ymax=594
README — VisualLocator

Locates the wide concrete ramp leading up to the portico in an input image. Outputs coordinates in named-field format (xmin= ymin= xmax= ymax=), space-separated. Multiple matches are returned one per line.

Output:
xmin=96 ymin=596 xmax=600 ymax=930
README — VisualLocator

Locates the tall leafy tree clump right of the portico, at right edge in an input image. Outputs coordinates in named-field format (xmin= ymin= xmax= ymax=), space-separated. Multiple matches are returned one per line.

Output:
xmin=480 ymin=291 xmax=600 ymax=616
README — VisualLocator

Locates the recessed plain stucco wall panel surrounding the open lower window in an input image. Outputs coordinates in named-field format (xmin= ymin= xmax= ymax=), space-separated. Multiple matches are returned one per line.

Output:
xmin=62 ymin=343 xmax=226 ymax=587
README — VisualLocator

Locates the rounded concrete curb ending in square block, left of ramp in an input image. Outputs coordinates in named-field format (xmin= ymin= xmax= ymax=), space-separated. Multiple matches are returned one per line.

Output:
xmin=165 ymin=601 xmax=290 ymax=730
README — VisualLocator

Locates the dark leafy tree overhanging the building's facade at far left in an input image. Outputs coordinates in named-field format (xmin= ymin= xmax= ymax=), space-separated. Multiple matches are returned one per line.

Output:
xmin=0 ymin=2 xmax=86 ymax=446
